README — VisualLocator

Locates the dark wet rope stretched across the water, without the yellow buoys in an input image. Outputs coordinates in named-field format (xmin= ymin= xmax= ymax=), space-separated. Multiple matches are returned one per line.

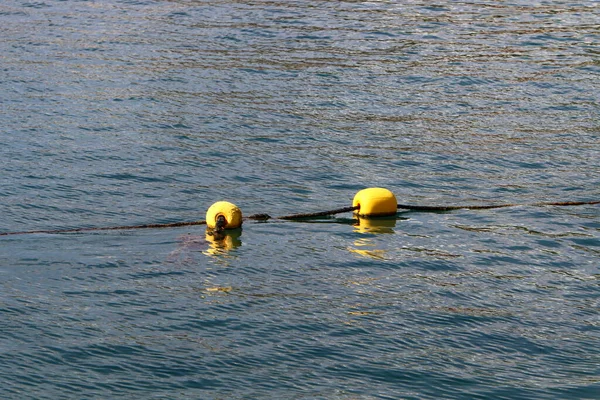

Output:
xmin=0 ymin=200 xmax=600 ymax=236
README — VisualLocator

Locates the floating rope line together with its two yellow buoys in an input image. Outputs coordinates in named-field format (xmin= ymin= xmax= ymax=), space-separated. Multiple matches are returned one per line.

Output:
xmin=0 ymin=188 xmax=600 ymax=236
